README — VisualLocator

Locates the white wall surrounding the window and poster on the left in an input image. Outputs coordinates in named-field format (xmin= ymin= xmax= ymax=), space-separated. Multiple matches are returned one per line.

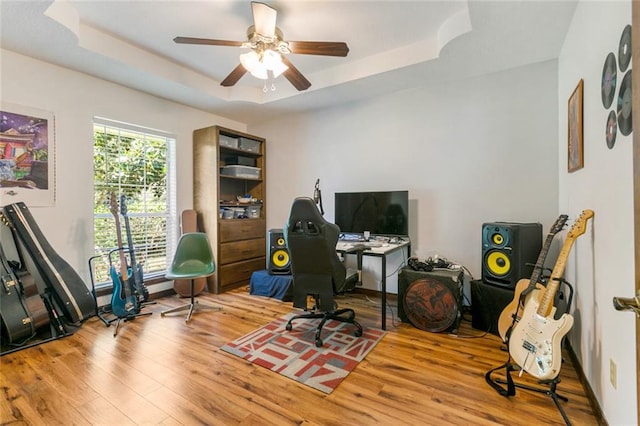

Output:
xmin=0 ymin=50 xmax=246 ymax=286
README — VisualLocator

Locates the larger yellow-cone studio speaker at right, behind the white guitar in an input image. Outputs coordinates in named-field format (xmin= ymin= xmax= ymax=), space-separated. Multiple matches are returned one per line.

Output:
xmin=482 ymin=222 xmax=542 ymax=288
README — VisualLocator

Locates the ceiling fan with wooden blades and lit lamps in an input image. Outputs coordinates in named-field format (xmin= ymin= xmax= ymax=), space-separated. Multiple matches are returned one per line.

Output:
xmin=173 ymin=1 xmax=349 ymax=90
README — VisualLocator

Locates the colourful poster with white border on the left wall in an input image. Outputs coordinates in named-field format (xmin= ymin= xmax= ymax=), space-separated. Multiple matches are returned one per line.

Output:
xmin=0 ymin=102 xmax=55 ymax=206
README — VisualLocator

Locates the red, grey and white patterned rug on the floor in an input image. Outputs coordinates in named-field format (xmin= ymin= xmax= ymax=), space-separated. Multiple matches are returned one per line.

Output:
xmin=222 ymin=313 xmax=386 ymax=393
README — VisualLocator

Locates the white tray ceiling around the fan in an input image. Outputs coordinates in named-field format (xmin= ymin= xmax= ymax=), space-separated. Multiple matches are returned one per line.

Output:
xmin=0 ymin=0 xmax=576 ymax=123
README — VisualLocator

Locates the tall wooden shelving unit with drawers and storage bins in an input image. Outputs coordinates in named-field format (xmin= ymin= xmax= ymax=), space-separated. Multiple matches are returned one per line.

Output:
xmin=193 ymin=126 xmax=266 ymax=293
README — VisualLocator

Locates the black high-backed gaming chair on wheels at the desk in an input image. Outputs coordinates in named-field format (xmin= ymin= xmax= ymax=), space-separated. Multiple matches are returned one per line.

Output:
xmin=284 ymin=197 xmax=362 ymax=347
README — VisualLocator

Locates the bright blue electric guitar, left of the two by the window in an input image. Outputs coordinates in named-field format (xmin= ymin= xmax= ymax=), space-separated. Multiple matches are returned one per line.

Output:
xmin=109 ymin=193 xmax=140 ymax=318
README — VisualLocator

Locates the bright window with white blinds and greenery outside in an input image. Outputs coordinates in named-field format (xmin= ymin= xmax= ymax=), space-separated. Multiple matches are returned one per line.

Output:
xmin=92 ymin=119 xmax=177 ymax=287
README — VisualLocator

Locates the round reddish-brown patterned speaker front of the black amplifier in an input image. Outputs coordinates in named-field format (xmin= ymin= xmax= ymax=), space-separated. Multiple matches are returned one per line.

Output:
xmin=404 ymin=278 xmax=459 ymax=333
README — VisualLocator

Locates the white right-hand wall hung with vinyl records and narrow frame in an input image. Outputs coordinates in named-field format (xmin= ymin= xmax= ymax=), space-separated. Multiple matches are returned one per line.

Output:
xmin=558 ymin=1 xmax=638 ymax=425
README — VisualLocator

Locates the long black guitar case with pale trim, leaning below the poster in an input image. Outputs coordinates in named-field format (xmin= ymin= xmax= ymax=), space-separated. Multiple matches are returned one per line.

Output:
xmin=3 ymin=202 xmax=96 ymax=323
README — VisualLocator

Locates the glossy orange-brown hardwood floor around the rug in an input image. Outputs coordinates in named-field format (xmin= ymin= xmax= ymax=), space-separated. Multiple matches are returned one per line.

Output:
xmin=0 ymin=288 xmax=598 ymax=425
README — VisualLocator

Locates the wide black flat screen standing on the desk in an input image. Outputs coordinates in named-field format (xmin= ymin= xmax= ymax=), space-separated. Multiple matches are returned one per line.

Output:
xmin=334 ymin=191 xmax=409 ymax=236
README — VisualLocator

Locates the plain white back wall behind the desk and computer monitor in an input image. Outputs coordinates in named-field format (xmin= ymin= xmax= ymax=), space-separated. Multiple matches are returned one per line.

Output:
xmin=249 ymin=61 xmax=558 ymax=291
